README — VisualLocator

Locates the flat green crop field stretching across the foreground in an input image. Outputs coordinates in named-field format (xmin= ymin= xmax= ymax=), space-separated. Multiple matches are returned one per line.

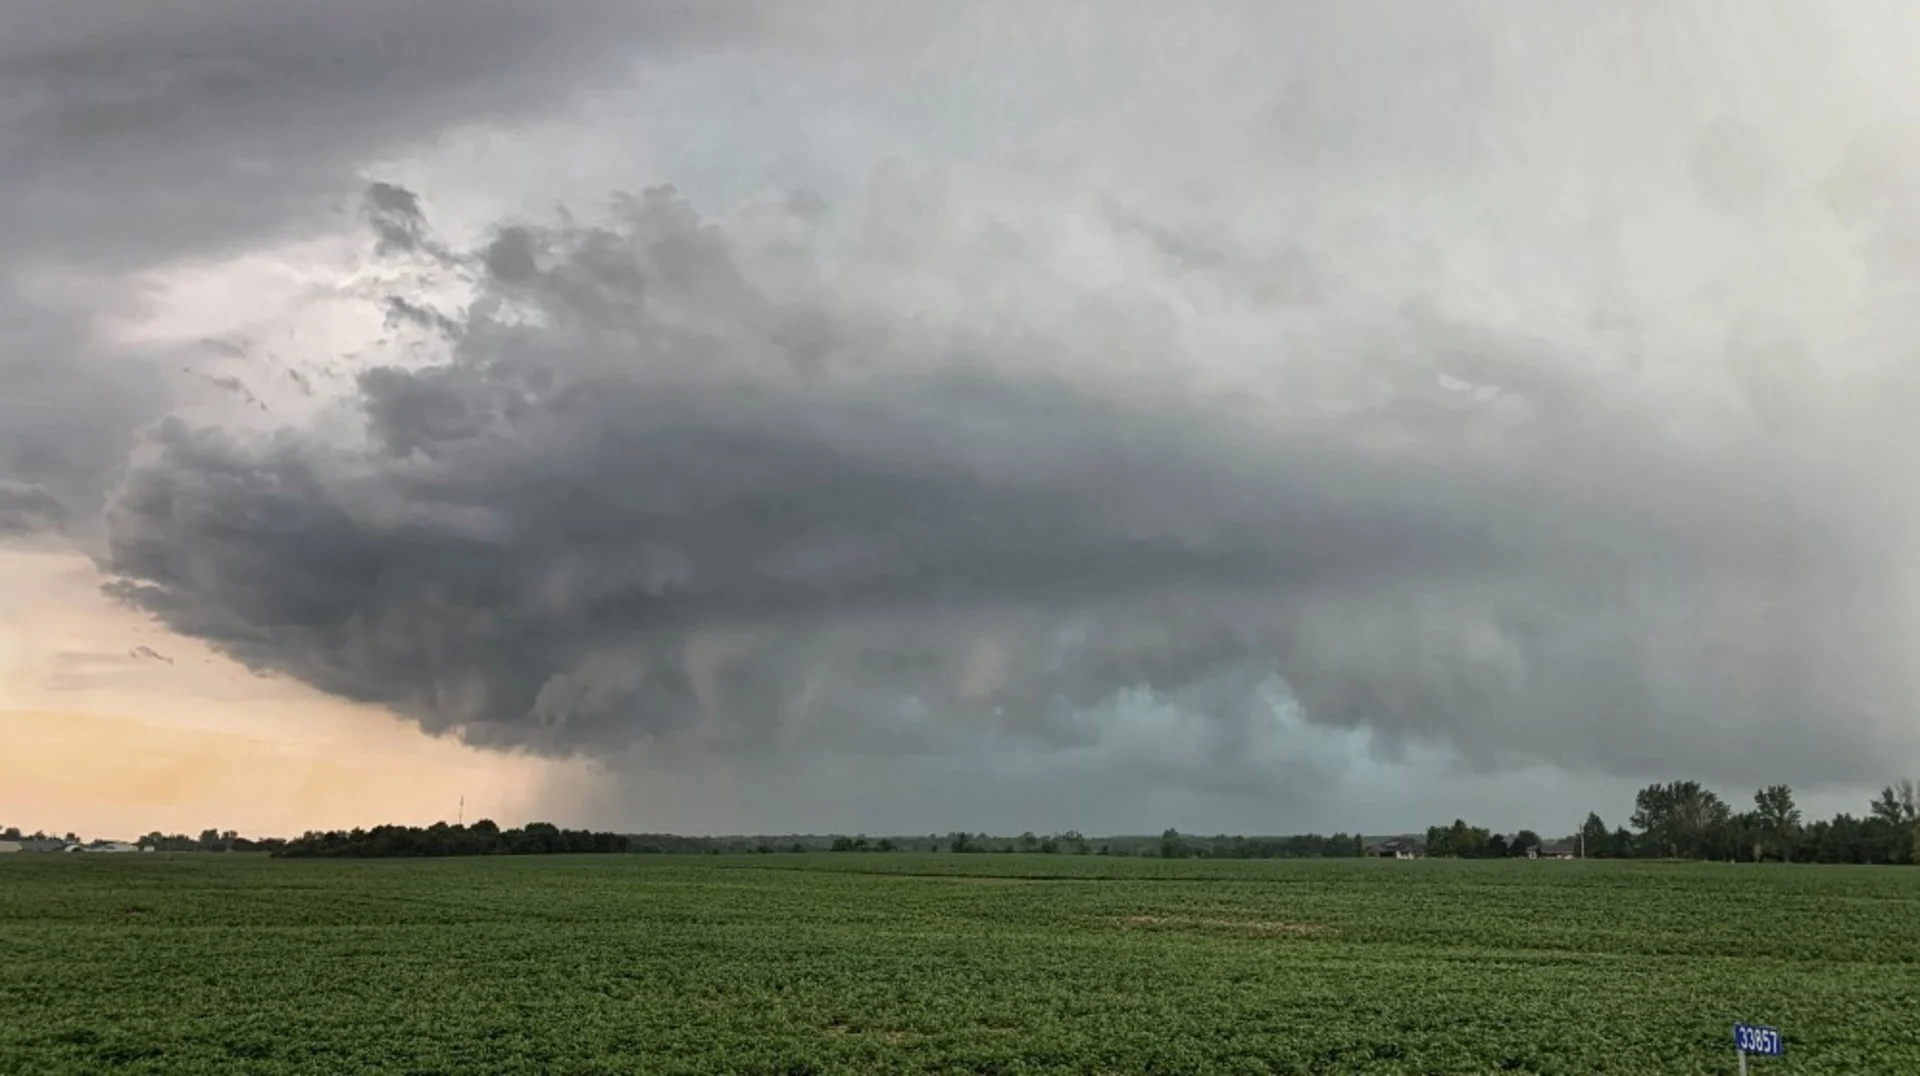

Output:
xmin=0 ymin=855 xmax=1920 ymax=1076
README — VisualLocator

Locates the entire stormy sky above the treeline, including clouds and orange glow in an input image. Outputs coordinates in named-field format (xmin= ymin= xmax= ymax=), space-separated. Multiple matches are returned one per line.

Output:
xmin=0 ymin=0 xmax=1920 ymax=834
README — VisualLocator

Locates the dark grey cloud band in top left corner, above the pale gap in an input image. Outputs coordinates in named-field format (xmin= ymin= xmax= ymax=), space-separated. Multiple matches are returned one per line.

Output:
xmin=0 ymin=0 xmax=753 ymax=269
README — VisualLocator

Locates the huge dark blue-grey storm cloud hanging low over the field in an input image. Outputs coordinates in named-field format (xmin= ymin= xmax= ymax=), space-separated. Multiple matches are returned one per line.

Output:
xmin=109 ymin=190 xmax=1920 ymax=780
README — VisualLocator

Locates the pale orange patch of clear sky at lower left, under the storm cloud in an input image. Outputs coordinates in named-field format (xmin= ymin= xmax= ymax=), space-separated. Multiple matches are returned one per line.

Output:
xmin=0 ymin=550 xmax=568 ymax=838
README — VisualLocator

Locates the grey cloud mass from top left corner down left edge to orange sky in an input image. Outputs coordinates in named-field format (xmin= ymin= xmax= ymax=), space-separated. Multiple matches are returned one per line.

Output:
xmin=0 ymin=0 xmax=751 ymax=534
